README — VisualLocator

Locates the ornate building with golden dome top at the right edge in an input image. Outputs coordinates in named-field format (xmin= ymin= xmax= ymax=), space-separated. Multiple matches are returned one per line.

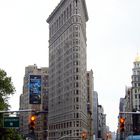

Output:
xmin=117 ymin=56 xmax=140 ymax=139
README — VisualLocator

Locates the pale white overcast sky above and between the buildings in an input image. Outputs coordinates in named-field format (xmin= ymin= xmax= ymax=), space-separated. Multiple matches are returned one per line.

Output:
xmin=0 ymin=0 xmax=140 ymax=131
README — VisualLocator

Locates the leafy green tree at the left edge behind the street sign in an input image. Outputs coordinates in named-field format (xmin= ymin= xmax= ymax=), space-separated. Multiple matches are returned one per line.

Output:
xmin=0 ymin=69 xmax=22 ymax=140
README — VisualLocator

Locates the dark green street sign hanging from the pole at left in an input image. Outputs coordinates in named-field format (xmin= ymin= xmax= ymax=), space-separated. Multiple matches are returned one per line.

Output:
xmin=3 ymin=117 xmax=19 ymax=128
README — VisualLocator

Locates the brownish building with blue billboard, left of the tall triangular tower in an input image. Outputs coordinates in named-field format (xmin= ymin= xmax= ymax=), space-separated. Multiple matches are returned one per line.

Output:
xmin=20 ymin=65 xmax=48 ymax=140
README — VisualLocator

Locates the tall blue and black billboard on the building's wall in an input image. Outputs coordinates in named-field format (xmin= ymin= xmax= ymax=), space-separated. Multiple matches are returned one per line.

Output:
xmin=29 ymin=75 xmax=41 ymax=104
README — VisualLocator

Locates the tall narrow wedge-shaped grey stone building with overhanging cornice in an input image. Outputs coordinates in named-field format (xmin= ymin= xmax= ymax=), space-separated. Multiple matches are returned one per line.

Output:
xmin=47 ymin=0 xmax=88 ymax=140
